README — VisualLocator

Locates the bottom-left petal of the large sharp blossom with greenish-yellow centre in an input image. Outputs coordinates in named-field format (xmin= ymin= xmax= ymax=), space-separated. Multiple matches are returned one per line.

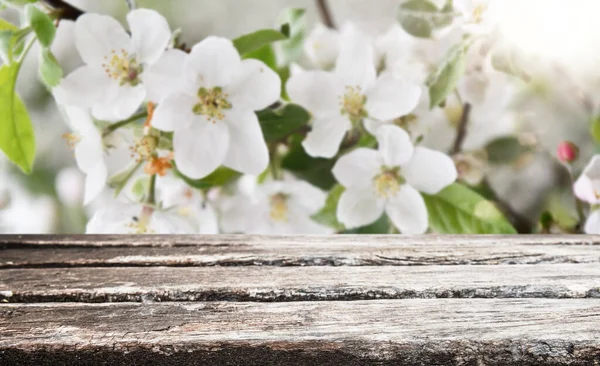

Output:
xmin=173 ymin=117 xmax=229 ymax=179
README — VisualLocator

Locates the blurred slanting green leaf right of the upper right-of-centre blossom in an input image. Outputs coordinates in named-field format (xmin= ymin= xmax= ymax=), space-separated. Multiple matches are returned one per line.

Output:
xmin=427 ymin=43 xmax=470 ymax=109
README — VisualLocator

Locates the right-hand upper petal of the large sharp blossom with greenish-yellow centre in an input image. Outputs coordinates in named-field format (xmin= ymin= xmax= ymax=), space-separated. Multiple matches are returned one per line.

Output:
xmin=227 ymin=59 xmax=281 ymax=111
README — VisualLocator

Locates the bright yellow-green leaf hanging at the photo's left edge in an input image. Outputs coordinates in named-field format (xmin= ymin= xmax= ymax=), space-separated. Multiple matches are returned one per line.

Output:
xmin=0 ymin=63 xmax=35 ymax=174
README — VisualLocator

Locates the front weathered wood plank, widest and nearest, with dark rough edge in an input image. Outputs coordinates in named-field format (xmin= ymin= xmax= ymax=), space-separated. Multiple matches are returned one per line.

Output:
xmin=0 ymin=299 xmax=600 ymax=366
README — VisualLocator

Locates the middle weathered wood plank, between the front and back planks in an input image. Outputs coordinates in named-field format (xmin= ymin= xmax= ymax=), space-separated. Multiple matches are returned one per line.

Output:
xmin=0 ymin=263 xmax=600 ymax=303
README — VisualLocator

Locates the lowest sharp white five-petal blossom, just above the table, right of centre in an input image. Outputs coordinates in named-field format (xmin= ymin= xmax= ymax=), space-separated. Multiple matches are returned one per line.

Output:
xmin=333 ymin=125 xmax=457 ymax=234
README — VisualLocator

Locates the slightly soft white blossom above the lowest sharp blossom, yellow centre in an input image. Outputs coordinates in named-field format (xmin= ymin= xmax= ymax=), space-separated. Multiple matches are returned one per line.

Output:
xmin=287 ymin=25 xmax=421 ymax=158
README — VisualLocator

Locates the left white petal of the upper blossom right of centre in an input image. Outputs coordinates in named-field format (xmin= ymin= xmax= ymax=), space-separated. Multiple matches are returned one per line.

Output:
xmin=286 ymin=71 xmax=344 ymax=116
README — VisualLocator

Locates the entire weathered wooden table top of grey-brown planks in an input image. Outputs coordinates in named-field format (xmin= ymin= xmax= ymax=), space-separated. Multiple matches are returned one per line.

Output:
xmin=0 ymin=236 xmax=600 ymax=366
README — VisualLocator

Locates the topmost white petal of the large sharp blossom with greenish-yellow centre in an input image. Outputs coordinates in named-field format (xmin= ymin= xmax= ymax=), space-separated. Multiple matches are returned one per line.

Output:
xmin=184 ymin=36 xmax=242 ymax=87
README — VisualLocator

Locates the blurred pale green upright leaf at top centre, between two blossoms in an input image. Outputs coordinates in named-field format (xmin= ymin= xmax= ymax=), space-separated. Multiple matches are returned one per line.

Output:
xmin=277 ymin=8 xmax=306 ymax=66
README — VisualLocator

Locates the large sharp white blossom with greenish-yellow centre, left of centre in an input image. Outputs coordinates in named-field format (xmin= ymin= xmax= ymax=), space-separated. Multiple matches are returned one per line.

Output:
xmin=152 ymin=37 xmax=281 ymax=179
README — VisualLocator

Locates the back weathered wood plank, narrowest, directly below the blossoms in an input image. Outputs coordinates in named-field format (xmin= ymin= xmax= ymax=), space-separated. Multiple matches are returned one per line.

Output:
xmin=0 ymin=236 xmax=600 ymax=268
